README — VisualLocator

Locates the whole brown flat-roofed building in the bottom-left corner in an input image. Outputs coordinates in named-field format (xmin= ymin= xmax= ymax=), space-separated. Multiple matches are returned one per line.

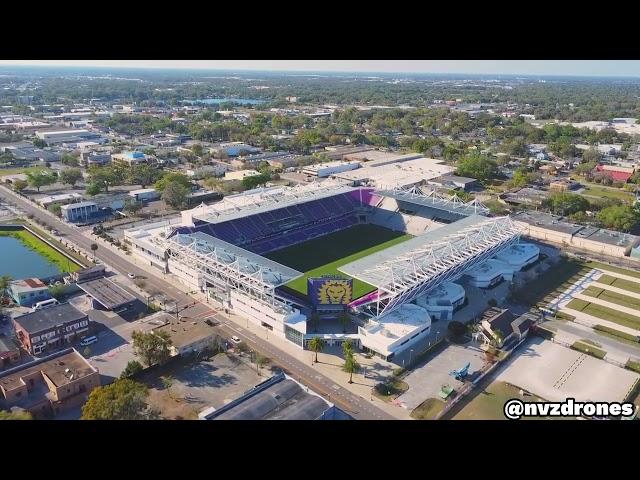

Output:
xmin=0 ymin=348 xmax=100 ymax=419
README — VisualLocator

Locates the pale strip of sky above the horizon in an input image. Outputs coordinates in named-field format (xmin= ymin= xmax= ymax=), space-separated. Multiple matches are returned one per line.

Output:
xmin=0 ymin=60 xmax=640 ymax=77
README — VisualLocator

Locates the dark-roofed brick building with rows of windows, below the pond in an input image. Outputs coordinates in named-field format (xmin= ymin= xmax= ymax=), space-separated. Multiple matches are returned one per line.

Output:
xmin=13 ymin=303 xmax=89 ymax=355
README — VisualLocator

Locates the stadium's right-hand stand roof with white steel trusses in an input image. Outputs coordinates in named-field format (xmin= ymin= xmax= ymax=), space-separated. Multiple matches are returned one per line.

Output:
xmin=339 ymin=215 xmax=521 ymax=317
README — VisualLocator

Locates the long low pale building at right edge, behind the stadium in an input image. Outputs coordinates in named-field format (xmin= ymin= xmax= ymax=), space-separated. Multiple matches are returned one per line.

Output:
xmin=513 ymin=211 xmax=640 ymax=258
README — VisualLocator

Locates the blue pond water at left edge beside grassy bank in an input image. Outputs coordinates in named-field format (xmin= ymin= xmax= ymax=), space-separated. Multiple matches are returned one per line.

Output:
xmin=0 ymin=237 xmax=60 ymax=280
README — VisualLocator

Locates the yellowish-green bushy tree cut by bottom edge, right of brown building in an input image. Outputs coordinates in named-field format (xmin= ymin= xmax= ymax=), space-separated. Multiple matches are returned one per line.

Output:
xmin=82 ymin=378 xmax=151 ymax=420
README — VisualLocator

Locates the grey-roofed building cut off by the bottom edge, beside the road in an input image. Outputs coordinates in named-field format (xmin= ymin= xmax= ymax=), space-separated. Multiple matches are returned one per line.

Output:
xmin=199 ymin=373 xmax=351 ymax=420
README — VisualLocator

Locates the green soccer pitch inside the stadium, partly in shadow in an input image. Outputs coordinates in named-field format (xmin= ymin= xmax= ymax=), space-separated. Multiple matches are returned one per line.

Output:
xmin=265 ymin=225 xmax=412 ymax=298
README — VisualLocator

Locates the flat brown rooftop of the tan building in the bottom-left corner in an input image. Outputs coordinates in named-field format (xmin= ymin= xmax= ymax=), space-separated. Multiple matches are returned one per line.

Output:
xmin=0 ymin=348 xmax=97 ymax=390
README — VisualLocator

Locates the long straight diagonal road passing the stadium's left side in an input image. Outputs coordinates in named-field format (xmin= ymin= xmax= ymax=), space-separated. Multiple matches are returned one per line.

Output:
xmin=0 ymin=187 xmax=394 ymax=420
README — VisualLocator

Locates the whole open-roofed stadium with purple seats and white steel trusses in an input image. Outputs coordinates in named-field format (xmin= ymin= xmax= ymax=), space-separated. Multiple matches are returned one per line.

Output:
xmin=125 ymin=180 xmax=538 ymax=359
